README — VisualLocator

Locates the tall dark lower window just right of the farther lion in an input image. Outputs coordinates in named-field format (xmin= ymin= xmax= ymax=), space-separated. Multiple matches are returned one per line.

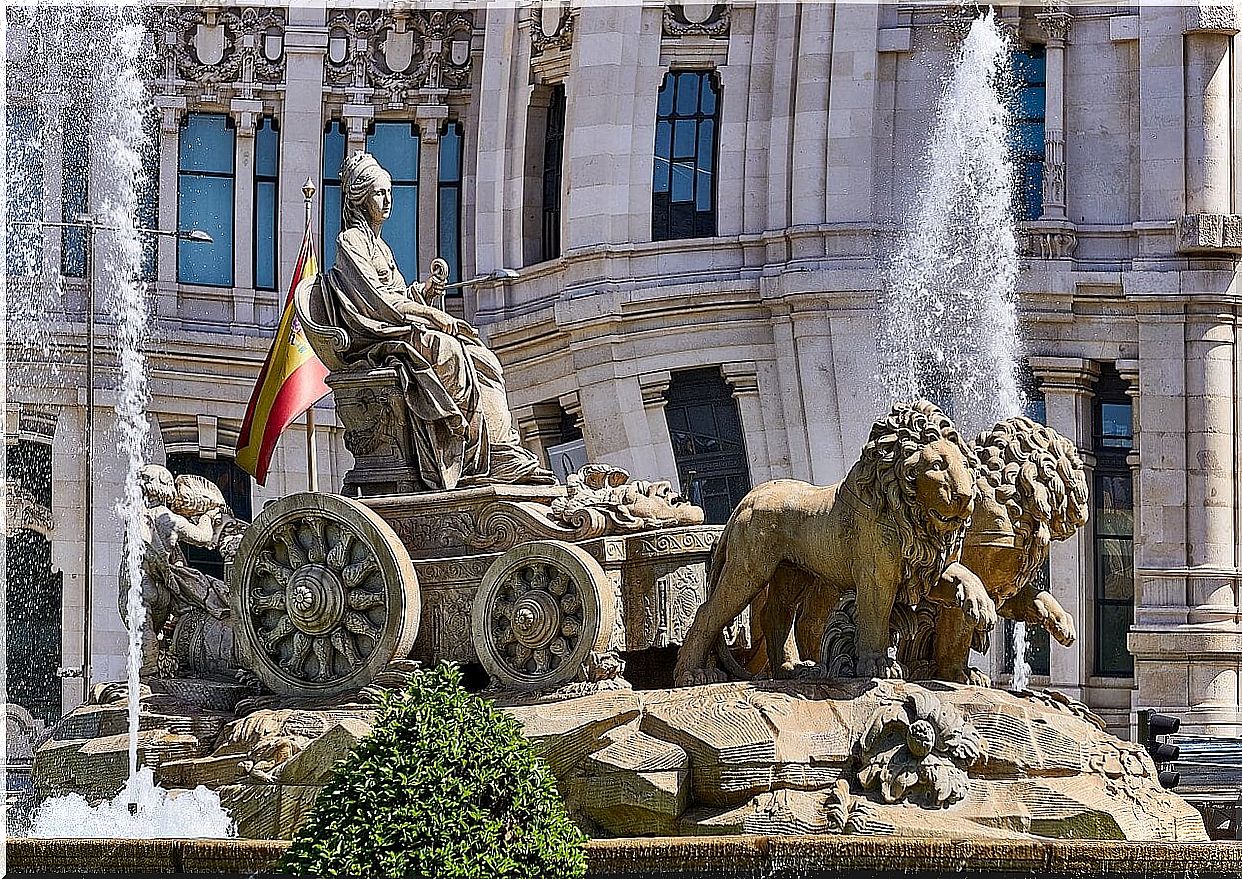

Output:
xmin=1092 ymin=366 xmax=1134 ymax=678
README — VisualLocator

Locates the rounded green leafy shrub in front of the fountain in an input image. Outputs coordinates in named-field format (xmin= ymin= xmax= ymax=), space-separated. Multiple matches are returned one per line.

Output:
xmin=281 ymin=663 xmax=586 ymax=879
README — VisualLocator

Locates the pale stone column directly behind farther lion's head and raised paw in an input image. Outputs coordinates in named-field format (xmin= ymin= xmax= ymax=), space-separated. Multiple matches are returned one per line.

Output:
xmin=1031 ymin=358 xmax=1099 ymax=699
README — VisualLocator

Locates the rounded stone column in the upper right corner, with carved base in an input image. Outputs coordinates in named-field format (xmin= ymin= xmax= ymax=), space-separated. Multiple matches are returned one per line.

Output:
xmin=1177 ymin=4 xmax=1242 ymax=251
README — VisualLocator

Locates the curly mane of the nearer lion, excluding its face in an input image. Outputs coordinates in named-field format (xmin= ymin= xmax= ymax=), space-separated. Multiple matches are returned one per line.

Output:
xmin=857 ymin=400 xmax=979 ymax=607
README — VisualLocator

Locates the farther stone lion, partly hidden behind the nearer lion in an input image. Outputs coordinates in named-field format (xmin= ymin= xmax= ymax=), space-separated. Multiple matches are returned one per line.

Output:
xmin=934 ymin=416 xmax=1087 ymax=685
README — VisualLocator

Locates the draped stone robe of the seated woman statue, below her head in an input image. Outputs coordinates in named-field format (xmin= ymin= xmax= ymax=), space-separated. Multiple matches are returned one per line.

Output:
xmin=323 ymin=227 xmax=550 ymax=490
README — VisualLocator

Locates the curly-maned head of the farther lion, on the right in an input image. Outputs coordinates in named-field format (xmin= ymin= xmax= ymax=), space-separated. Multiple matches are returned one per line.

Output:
xmin=975 ymin=415 xmax=1087 ymax=582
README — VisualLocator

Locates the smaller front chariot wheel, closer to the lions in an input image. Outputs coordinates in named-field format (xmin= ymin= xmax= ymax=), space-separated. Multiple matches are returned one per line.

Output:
xmin=471 ymin=540 xmax=617 ymax=690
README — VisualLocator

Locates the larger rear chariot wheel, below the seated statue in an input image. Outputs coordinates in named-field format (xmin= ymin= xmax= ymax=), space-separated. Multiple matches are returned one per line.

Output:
xmin=229 ymin=492 xmax=421 ymax=695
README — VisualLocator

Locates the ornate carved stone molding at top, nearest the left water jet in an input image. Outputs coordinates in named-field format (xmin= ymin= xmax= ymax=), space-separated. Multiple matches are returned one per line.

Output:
xmin=158 ymin=5 xmax=286 ymax=98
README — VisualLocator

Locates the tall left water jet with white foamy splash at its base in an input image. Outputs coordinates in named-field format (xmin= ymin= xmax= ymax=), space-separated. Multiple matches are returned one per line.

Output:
xmin=10 ymin=0 xmax=231 ymax=837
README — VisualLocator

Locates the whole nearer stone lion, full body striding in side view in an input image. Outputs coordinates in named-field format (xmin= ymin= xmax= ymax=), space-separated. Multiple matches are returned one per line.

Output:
xmin=673 ymin=401 xmax=996 ymax=687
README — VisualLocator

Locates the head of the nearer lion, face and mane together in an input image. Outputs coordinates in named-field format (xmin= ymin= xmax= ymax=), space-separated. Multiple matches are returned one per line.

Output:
xmin=857 ymin=400 xmax=979 ymax=606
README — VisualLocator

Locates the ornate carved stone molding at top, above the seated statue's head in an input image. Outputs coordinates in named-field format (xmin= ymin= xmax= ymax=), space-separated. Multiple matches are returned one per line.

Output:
xmin=324 ymin=9 xmax=474 ymax=103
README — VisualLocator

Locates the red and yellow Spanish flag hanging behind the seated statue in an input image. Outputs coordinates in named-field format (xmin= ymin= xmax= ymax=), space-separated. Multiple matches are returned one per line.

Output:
xmin=236 ymin=222 xmax=329 ymax=485
